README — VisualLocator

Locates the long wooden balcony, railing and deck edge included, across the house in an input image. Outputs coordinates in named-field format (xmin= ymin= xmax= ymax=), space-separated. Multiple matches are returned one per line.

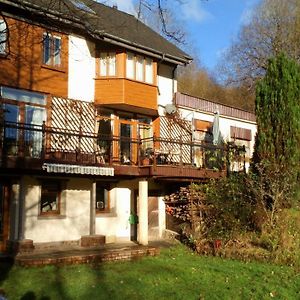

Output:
xmin=0 ymin=122 xmax=245 ymax=181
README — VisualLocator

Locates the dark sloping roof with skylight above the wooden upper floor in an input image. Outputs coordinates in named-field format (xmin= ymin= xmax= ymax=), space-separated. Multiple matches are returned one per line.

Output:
xmin=1 ymin=0 xmax=192 ymax=64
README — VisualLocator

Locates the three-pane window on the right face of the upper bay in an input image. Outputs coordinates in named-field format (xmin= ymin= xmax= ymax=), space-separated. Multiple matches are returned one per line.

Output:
xmin=126 ymin=52 xmax=153 ymax=84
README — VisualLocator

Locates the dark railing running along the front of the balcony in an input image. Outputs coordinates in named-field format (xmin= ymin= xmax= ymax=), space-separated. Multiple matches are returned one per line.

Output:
xmin=0 ymin=122 xmax=245 ymax=170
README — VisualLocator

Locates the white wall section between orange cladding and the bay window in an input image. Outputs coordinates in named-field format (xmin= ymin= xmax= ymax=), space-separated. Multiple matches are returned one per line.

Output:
xmin=68 ymin=35 xmax=95 ymax=102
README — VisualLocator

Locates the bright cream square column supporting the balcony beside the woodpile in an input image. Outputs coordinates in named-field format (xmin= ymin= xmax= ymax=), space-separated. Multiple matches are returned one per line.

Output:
xmin=138 ymin=180 xmax=148 ymax=245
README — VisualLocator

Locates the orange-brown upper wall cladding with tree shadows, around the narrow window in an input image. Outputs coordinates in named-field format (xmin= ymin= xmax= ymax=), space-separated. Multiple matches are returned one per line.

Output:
xmin=0 ymin=17 xmax=68 ymax=97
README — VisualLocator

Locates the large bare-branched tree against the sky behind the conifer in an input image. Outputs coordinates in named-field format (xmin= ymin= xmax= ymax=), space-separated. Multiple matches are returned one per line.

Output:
xmin=220 ymin=0 xmax=300 ymax=93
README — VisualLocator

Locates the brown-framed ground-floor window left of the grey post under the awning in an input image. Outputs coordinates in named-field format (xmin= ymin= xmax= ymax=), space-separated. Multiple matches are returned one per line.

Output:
xmin=40 ymin=181 xmax=61 ymax=215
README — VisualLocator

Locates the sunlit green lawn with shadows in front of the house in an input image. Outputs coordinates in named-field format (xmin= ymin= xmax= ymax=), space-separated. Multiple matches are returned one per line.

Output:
xmin=0 ymin=246 xmax=300 ymax=300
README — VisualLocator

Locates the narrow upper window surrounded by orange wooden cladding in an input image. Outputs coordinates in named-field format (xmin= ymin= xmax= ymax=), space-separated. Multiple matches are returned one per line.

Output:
xmin=43 ymin=32 xmax=61 ymax=67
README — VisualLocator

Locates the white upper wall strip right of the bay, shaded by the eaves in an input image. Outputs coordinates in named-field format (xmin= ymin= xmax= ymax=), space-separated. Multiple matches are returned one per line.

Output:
xmin=157 ymin=64 xmax=177 ymax=106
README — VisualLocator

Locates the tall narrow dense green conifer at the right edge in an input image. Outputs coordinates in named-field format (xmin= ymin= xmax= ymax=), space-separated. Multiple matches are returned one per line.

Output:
xmin=253 ymin=54 xmax=300 ymax=208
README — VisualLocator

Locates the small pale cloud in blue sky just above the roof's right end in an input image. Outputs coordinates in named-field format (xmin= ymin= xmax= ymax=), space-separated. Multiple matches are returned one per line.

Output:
xmin=180 ymin=0 xmax=213 ymax=23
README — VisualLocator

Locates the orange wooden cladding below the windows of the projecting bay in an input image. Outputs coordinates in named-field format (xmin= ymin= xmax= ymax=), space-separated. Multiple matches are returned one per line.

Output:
xmin=95 ymin=78 xmax=157 ymax=110
